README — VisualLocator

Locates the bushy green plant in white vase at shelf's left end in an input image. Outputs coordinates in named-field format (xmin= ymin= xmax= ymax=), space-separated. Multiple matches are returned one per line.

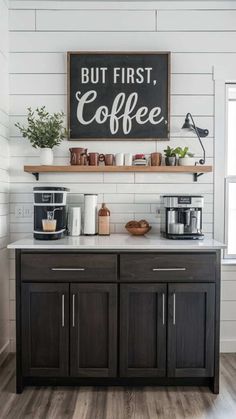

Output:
xmin=15 ymin=106 xmax=67 ymax=165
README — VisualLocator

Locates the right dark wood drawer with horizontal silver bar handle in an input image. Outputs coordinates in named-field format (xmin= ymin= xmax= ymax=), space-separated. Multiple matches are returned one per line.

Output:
xmin=120 ymin=253 xmax=216 ymax=282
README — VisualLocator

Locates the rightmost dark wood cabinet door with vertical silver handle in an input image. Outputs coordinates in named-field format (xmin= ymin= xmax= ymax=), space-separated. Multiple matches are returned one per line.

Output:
xmin=168 ymin=283 xmax=215 ymax=377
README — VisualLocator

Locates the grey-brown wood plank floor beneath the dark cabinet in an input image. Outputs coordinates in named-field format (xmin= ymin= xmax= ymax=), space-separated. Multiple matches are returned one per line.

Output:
xmin=0 ymin=354 xmax=236 ymax=419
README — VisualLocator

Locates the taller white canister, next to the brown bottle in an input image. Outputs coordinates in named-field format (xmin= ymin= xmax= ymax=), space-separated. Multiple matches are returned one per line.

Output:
xmin=84 ymin=194 xmax=98 ymax=235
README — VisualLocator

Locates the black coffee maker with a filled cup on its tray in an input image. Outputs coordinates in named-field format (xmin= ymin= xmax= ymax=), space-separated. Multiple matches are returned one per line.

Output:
xmin=34 ymin=186 xmax=69 ymax=240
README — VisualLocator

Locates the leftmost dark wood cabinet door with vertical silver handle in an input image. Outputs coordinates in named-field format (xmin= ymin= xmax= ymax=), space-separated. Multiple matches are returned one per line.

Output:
xmin=21 ymin=283 xmax=69 ymax=377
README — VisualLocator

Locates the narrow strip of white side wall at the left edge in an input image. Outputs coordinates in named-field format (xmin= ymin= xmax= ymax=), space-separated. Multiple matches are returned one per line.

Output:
xmin=0 ymin=0 xmax=9 ymax=360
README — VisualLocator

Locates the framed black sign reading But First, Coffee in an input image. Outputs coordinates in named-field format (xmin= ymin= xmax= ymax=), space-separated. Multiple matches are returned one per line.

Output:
xmin=67 ymin=52 xmax=170 ymax=140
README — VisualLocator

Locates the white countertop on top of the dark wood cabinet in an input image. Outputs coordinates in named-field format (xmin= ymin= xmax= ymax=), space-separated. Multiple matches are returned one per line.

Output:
xmin=8 ymin=234 xmax=225 ymax=251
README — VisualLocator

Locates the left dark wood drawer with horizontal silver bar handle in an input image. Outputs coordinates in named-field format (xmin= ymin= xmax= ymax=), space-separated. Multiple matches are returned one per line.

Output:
xmin=21 ymin=253 xmax=117 ymax=282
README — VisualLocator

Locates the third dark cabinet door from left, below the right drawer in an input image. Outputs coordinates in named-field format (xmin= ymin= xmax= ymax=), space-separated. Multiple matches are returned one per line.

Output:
xmin=120 ymin=284 xmax=167 ymax=377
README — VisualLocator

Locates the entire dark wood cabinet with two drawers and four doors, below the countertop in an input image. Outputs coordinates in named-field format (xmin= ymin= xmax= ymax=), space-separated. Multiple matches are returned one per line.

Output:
xmin=16 ymin=250 xmax=220 ymax=393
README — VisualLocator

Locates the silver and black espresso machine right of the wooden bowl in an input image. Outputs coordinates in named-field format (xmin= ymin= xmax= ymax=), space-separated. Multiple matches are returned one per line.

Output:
xmin=161 ymin=195 xmax=204 ymax=240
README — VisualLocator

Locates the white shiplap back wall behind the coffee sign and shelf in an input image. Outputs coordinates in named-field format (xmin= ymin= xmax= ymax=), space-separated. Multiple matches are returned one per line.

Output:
xmin=10 ymin=0 xmax=236 ymax=350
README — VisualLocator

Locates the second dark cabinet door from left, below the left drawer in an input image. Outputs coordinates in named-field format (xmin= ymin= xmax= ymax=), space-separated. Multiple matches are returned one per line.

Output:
xmin=70 ymin=284 xmax=117 ymax=377
